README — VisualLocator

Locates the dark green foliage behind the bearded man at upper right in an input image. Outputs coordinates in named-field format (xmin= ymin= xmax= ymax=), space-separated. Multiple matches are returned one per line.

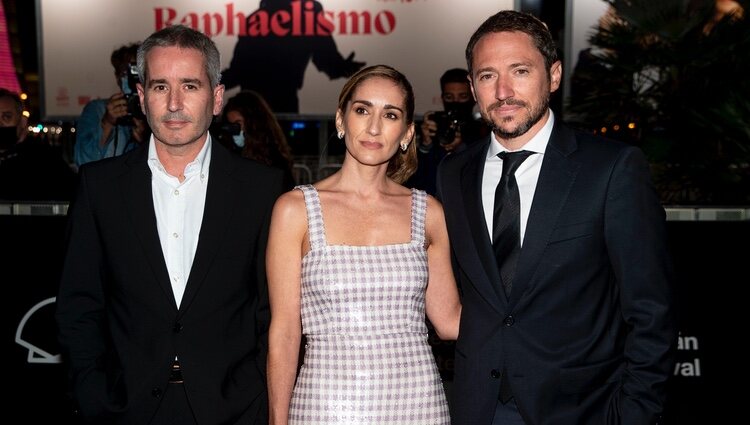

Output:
xmin=567 ymin=0 xmax=750 ymax=205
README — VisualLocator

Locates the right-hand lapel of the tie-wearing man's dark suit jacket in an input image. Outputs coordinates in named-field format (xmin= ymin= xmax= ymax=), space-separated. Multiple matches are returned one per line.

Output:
xmin=510 ymin=121 xmax=581 ymax=309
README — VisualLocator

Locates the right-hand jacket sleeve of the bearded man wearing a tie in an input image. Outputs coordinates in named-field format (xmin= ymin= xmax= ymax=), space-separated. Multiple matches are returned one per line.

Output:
xmin=604 ymin=148 xmax=677 ymax=424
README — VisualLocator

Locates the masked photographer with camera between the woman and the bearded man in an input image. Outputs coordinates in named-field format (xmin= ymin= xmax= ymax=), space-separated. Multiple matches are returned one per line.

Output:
xmin=405 ymin=68 xmax=489 ymax=195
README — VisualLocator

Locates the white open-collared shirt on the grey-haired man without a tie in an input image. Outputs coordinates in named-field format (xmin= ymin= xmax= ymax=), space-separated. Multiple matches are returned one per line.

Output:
xmin=148 ymin=135 xmax=211 ymax=308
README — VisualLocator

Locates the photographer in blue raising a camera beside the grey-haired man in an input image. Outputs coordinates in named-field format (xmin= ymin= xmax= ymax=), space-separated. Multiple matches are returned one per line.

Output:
xmin=73 ymin=43 xmax=149 ymax=166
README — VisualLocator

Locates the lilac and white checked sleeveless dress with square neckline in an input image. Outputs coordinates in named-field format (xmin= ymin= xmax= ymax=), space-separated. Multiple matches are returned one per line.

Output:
xmin=289 ymin=185 xmax=450 ymax=425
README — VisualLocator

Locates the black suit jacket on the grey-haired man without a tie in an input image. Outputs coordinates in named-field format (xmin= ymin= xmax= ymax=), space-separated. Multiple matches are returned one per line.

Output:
xmin=56 ymin=142 xmax=282 ymax=424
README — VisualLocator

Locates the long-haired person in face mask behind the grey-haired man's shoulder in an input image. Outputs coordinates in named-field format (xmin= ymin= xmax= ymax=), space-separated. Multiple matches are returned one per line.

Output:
xmin=220 ymin=90 xmax=294 ymax=189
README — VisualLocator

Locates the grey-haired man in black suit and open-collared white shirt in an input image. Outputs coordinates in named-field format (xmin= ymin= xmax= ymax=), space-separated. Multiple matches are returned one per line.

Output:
xmin=57 ymin=26 xmax=282 ymax=425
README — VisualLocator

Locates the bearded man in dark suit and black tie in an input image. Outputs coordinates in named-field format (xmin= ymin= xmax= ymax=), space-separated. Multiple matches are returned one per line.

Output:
xmin=438 ymin=11 xmax=677 ymax=425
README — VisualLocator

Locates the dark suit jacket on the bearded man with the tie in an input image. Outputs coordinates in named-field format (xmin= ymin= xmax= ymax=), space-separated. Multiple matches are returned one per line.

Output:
xmin=438 ymin=122 xmax=677 ymax=425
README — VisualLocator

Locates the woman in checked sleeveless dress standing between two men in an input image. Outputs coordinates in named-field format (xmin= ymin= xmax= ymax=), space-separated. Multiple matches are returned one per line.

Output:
xmin=266 ymin=65 xmax=461 ymax=425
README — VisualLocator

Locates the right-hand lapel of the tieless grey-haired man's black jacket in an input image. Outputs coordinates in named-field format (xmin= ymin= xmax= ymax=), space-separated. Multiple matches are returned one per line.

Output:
xmin=180 ymin=143 xmax=237 ymax=316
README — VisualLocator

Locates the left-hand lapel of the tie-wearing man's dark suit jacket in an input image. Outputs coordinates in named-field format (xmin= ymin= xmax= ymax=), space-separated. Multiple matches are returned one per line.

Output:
xmin=456 ymin=138 xmax=507 ymax=312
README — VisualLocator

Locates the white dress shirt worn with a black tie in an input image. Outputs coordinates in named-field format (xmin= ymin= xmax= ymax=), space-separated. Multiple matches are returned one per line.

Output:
xmin=482 ymin=110 xmax=555 ymax=245
